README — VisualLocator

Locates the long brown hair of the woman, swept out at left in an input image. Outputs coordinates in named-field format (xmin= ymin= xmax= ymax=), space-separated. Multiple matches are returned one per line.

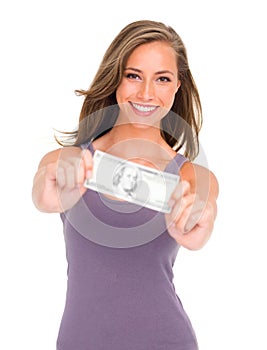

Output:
xmin=57 ymin=20 xmax=202 ymax=160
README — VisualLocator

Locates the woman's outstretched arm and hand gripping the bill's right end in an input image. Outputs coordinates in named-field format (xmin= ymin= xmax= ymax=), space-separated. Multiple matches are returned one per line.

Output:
xmin=166 ymin=162 xmax=219 ymax=250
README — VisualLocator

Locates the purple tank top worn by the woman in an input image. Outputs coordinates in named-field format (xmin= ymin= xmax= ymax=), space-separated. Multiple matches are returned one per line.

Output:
xmin=57 ymin=145 xmax=198 ymax=350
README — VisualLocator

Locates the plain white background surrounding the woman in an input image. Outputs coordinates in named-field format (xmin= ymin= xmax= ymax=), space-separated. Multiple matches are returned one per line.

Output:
xmin=0 ymin=0 xmax=267 ymax=350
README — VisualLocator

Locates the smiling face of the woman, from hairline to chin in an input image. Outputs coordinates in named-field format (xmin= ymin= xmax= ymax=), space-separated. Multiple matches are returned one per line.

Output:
xmin=116 ymin=41 xmax=180 ymax=126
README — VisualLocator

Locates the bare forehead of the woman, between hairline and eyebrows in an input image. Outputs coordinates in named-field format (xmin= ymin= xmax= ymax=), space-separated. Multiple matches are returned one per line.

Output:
xmin=126 ymin=41 xmax=177 ymax=69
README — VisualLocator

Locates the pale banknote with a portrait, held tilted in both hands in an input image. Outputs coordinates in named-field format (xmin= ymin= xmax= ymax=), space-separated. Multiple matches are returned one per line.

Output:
xmin=84 ymin=150 xmax=180 ymax=213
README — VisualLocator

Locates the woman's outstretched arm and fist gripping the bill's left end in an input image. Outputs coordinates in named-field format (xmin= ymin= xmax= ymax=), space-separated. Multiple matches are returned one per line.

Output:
xmin=32 ymin=147 xmax=93 ymax=213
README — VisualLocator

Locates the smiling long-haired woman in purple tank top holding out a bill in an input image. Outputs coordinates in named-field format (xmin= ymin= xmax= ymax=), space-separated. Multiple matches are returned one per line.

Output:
xmin=33 ymin=21 xmax=218 ymax=350
